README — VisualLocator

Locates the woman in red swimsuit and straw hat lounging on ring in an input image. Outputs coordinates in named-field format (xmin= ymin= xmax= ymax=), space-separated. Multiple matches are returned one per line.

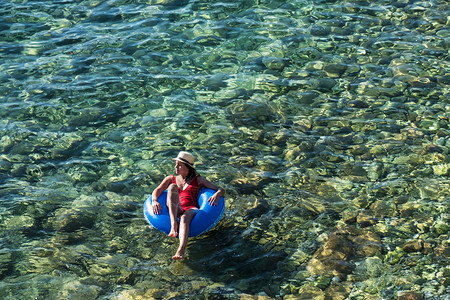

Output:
xmin=152 ymin=151 xmax=225 ymax=259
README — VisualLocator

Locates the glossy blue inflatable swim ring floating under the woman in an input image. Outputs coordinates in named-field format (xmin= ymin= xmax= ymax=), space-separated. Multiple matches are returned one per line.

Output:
xmin=144 ymin=188 xmax=225 ymax=237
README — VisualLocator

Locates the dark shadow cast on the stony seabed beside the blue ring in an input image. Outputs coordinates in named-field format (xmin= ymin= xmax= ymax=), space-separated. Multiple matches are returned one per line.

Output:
xmin=186 ymin=221 xmax=288 ymax=296
